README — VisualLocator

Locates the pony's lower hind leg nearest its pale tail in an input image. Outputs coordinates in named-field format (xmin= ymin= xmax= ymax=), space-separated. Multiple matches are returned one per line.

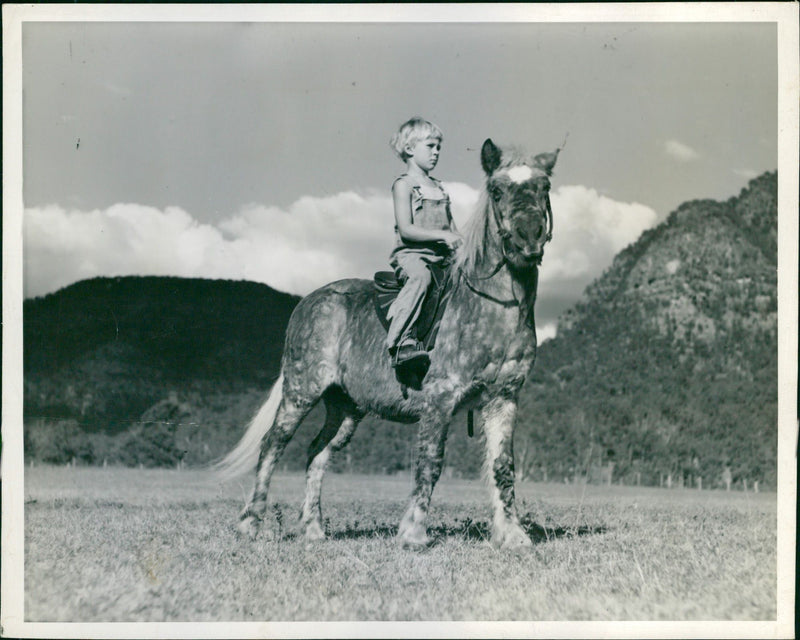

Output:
xmin=238 ymin=395 xmax=317 ymax=538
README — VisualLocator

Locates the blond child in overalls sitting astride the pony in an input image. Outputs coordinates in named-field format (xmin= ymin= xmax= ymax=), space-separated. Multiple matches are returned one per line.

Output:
xmin=386 ymin=117 xmax=461 ymax=367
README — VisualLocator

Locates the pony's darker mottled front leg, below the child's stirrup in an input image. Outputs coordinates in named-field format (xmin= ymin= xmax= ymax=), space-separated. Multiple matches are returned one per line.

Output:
xmin=397 ymin=413 xmax=449 ymax=549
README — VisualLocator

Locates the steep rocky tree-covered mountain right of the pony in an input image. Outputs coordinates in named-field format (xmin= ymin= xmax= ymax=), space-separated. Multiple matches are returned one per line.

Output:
xmin=518 ymin=172 xmax=777 ymax=486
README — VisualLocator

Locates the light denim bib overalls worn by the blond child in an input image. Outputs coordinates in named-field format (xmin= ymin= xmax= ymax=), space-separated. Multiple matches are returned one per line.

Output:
xmin=386 ymin=175 xmax=453 ymax=349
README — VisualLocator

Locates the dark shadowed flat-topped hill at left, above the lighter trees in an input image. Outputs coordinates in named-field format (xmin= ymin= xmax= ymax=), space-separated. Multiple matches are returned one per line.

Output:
xmin=23 ymin=277 xmax=298 ymax=460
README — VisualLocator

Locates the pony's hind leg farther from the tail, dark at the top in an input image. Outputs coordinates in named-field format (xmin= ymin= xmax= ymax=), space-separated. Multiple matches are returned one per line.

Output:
xmin=301 ymin=402 xmax=358 ymax=540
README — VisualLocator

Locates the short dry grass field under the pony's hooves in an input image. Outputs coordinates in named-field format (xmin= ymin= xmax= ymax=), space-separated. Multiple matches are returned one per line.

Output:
xmin=25 ymin=467 xmax=777 ymax=622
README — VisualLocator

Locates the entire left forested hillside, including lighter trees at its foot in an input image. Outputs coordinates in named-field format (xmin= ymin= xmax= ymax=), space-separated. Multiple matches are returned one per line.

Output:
xmin=23 ymin=277 xmax=298 ymax=465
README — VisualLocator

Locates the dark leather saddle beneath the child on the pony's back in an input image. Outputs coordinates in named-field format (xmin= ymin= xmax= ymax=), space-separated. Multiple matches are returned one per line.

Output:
xmin=373 ymin=264 xmax=453 ymax=351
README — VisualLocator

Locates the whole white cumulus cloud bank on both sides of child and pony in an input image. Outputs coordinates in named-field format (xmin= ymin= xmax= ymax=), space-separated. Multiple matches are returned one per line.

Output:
xmin=23 ymin=183 xmax=656 ymax=339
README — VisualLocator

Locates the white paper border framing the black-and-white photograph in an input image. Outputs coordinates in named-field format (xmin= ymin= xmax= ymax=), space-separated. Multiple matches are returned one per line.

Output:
xmin=0 ymin=2 xmax=800 ymax=638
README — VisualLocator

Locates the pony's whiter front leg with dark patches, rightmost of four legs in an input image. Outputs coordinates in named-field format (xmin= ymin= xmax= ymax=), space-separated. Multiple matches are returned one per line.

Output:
xmin=482 ymin=397 xmax=531 ymax=549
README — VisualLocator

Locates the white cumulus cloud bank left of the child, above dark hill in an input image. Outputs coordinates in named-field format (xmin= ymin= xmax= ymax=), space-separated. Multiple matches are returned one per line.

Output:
xmin=23 ymin=192 xmax=393 ymax=296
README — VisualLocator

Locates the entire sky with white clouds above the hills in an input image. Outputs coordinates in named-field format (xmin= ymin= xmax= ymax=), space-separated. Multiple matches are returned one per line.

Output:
xmin=22 ymin=15 xmax=778 ymax=338
